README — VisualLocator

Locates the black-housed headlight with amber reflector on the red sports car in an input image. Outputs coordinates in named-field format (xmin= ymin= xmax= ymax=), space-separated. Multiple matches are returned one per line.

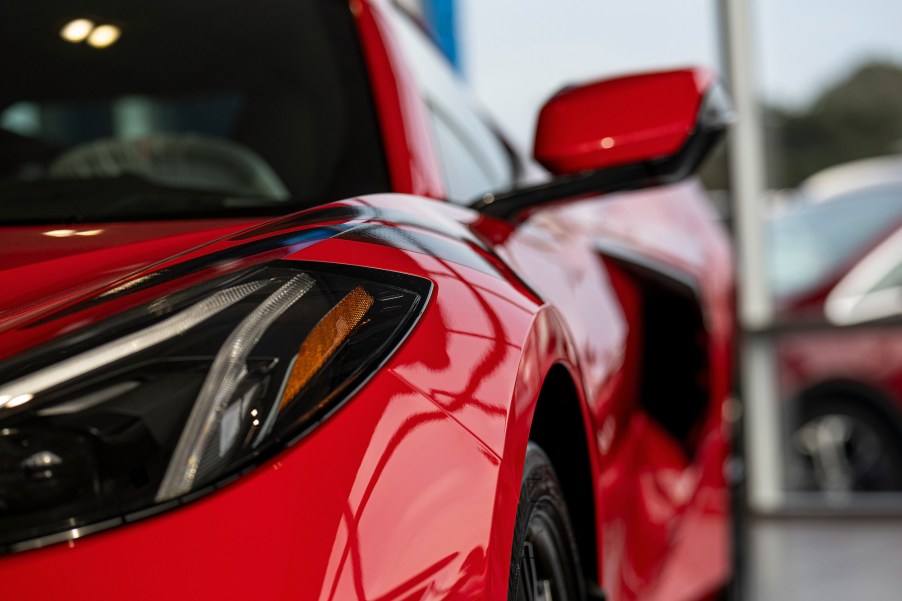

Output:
xmin=0 ymin=262 xmax=431 ymax=550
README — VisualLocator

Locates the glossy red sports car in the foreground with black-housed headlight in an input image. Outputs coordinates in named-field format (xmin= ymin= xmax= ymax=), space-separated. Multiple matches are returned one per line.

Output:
xmin=0 ymin=0 xmax=732 ymax=601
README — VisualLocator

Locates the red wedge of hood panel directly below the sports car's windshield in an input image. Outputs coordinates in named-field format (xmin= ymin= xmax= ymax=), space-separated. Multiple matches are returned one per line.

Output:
xmin=0 ymin=219 xmax=258 ymax=329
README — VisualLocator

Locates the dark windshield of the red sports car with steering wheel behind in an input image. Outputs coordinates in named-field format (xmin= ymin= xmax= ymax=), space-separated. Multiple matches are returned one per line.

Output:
xmin=0 ymin=0 xmax=388 ymax=223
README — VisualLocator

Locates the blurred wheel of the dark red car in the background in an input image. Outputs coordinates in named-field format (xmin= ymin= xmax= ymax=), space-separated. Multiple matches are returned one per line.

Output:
xmin=791 ymin=399 xmax=902 ymax=492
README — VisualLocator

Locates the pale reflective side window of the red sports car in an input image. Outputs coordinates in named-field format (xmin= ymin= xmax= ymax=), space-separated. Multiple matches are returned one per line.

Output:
xmin=393 ymin=7 xmax=516 ymax=203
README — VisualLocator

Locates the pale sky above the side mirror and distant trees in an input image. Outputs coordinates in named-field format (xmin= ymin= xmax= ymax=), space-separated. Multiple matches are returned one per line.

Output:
xmin=457 ymin=0 xmax=902 ymax=147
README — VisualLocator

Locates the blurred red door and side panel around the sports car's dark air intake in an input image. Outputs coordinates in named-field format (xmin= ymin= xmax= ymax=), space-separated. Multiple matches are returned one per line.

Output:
xmin=501 ymin=183 xmax=733 ymax=600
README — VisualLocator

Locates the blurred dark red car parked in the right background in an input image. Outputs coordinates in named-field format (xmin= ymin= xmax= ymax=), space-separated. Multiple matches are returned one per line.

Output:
xmin=770 ymin=157 xmax=902 ymax=493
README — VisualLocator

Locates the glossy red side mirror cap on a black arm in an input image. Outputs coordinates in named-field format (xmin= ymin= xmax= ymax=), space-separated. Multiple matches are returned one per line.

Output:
xmin=533 ymin=68 xmax=716 ymax=175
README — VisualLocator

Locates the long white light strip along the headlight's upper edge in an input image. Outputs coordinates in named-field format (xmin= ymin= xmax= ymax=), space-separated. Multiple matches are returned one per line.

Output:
xmin=0 ymin=281 xmax=267 ymax=409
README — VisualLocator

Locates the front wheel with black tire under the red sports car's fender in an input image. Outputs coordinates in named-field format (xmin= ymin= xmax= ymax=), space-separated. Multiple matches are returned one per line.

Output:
xmin=507 ymin=443 xmax=585 ymax=601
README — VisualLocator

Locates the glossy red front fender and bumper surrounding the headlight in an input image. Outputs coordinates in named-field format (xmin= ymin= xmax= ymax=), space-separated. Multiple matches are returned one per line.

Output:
xmin=0 ymin=197 xmax=542 ymax=599
